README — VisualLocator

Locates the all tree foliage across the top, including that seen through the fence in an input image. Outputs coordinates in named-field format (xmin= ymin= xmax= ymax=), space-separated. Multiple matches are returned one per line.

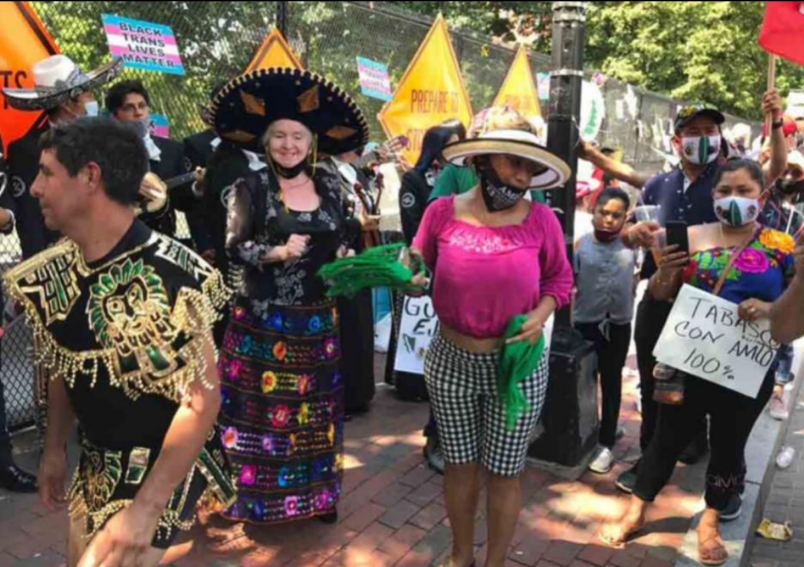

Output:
xmin=28 ymin=1 xmax=804 ymax=138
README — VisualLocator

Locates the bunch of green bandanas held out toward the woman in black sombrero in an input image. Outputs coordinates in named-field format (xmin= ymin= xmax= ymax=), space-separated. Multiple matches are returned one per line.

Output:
xmin=318 ymin=242 xmax=423 ymax=297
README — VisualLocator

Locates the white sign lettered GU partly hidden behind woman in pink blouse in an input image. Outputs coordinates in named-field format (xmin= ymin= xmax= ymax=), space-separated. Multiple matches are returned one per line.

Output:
xmin=394 ymin=297 xmax=438 ymax=375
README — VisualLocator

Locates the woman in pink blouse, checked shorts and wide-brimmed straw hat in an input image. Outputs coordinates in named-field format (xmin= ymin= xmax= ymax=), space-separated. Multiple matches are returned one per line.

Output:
xmin=413 ymin=110 xmax=573 ymax=567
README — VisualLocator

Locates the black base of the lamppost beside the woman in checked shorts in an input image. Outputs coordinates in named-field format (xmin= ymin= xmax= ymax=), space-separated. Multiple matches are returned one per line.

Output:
xmin=528 ymin=329 xmax=600 ymax=468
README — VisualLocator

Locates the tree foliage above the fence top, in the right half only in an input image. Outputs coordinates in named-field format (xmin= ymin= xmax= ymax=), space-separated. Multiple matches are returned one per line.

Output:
xmin=395 ymin=2 xmax=804 ymax=119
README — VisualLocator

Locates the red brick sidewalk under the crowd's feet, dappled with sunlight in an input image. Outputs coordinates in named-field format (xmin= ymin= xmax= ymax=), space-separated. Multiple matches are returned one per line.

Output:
xmin=0 ymin=360 xmax=708 ymax=567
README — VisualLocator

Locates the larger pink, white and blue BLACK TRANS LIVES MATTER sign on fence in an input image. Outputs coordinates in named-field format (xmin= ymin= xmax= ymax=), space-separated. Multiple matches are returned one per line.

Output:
xmin=101 ymin=14 xmax=184 ymax=75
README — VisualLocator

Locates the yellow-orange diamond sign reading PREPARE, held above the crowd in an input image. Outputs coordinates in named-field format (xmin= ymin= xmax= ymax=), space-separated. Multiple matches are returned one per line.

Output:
xmin=378 ymin=15 xmax=472 ymax=164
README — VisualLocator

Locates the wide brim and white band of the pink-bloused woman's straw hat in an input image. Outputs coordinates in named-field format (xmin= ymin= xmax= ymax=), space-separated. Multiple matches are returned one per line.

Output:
xmin=444 ymin=130 xmax=571 ymax=189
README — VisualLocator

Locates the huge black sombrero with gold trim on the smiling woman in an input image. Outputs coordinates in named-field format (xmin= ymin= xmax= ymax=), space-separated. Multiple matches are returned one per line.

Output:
xmin=211 ymin=67 xmax=369 ymax=155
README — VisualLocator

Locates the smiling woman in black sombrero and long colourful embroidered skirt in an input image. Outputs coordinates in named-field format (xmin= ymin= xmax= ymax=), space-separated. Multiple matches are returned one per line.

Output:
xmin=212 ymin=69 xmax=368 ymax=524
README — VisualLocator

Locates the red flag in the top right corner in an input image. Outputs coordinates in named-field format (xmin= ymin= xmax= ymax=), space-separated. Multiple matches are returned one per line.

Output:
xmin=759 ymin=2 xmax=804 ymax=65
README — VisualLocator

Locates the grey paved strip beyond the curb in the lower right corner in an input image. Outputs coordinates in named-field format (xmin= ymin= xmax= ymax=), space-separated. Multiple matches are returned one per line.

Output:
xmin=749 ymin=388 xmax=804 ymax=567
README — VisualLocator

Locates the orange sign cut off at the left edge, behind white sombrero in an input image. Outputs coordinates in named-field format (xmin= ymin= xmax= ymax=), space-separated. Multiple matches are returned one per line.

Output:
xmin=0 ymin=2 xmax=59 ymax=155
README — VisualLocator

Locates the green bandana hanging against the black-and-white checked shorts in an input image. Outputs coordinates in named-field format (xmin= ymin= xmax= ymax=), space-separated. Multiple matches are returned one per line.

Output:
xmin=497 ymin=315 xmax=545 ymax=431
